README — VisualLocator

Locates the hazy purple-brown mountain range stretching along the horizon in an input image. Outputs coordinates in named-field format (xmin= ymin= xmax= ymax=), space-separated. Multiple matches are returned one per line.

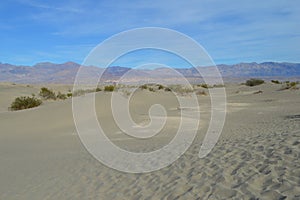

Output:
xmin=0 ymin=62 xmax=300 ymax=84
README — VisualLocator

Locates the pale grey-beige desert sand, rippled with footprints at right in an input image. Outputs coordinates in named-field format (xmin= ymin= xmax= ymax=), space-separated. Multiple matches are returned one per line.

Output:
xmin=0 ymin=83 xmax=300 ymax=200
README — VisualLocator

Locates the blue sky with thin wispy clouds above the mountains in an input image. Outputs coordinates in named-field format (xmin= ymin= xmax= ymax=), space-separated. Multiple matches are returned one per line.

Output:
xmin=0 ymin=0 xmax=300 ymax=67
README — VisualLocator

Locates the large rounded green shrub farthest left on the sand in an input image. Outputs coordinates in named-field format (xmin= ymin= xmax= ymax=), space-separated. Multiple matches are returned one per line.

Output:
xmin=10 ymin=96 xmax=42 ymax=110
